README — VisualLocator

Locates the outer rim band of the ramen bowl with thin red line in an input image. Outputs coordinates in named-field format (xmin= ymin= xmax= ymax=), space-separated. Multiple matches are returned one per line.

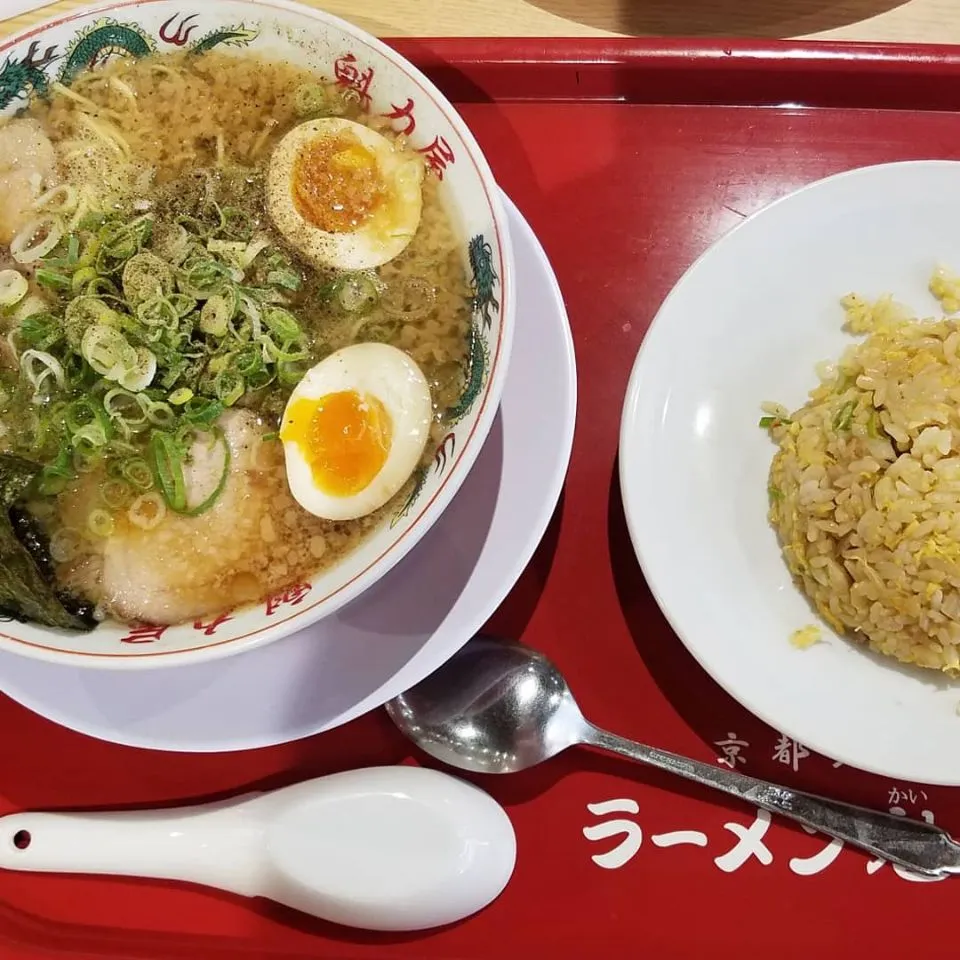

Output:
xmin=0 ymin=0 xmax=516 ymax=670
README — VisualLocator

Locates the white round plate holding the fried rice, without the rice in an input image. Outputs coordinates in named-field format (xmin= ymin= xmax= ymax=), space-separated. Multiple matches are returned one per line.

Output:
xmin=620 ymin=161 xmax=960 ymax=785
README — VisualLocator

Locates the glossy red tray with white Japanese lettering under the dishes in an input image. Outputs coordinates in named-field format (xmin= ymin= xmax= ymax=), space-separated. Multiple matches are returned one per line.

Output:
xmin=0 ymin=40 xmax=960 ymax=960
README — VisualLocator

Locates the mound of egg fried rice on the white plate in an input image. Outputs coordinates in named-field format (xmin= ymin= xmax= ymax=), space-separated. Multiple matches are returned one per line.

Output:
xmin=760 ymin=270 xmax=960 ymax=676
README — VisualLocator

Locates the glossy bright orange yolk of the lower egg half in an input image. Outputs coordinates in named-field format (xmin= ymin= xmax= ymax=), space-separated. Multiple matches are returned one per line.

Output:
xmin=280 ymin=390 xmax=393 ymax=497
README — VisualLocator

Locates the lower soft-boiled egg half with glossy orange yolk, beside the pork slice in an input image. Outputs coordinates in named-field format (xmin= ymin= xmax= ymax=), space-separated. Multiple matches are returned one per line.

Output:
xmin=280 ymin=343 xmax=433 ymax=520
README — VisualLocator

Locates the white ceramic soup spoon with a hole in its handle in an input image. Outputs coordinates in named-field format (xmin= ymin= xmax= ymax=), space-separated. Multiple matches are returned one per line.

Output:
xmin=0 ymin=767 xmax=516 ymax=930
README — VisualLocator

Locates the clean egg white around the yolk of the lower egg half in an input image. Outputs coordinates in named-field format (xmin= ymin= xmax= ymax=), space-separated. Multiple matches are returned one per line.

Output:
xmin=283 ymin=343 xmax=433 ymax=520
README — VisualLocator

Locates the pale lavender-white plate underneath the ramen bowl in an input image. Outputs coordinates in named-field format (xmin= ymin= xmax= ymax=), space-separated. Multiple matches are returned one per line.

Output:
xmin=0 ymin=193 xmax=577 ymax=752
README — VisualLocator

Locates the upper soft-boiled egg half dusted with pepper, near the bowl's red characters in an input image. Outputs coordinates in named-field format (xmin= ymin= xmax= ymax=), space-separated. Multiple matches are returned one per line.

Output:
xmin=266 ymin=117 xmax=424 ymax=270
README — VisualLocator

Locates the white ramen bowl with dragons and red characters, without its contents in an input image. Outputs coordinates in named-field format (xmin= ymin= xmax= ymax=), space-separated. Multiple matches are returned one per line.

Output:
xmin=0 ymin=0 xmax=514 ymax=668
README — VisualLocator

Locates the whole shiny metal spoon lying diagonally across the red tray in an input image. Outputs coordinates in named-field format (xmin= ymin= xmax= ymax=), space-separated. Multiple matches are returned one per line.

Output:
xmin=387 ymin=636 xmax=960 ymax=877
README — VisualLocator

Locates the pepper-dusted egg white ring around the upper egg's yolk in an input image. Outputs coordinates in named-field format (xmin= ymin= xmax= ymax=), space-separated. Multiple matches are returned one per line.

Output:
xmin=266 ymin=117 xmax=424 ymax=270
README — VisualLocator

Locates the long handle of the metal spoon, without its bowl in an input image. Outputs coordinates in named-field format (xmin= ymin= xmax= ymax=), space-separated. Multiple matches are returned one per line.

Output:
xmin=584 ymin=724 xmax=960 ymax=877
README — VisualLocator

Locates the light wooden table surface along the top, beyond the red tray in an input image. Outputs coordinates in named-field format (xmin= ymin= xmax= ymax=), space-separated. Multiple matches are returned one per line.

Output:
xmin=0 ymin=0 xmax=960 ymax=43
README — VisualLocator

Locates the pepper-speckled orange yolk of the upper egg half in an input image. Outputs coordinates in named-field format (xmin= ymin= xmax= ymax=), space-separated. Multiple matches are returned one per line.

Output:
xmin=292 ymin=133 xmax=384 ymax=233
